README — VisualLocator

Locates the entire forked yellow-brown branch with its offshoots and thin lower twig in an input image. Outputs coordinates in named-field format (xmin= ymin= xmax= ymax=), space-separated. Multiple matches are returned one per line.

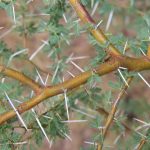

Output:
xmin=0 ymin=0 xmax=150 ymax=150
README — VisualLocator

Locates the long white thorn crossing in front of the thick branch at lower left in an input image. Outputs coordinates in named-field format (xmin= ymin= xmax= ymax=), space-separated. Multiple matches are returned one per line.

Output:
xmin=4 ymin=92 xmax=28 ymax=131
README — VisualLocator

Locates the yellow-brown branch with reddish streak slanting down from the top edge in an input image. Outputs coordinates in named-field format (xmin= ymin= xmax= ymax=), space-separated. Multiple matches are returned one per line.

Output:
xmin=69 ymin=0 xmax=121 ymax=55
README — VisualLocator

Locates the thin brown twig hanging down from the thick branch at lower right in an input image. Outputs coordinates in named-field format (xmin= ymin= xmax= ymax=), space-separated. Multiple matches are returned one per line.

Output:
xmin=97 ymin=77 xmax=132 ymax=150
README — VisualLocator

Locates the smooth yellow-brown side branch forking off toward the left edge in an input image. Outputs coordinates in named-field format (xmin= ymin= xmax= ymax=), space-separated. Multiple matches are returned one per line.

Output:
xmin=0 ymin=65 xmax=42 ymax=93
